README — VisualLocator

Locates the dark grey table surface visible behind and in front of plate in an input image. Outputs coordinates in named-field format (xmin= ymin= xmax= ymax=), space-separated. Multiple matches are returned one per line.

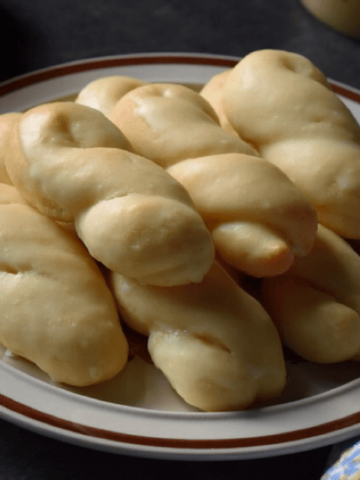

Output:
xmin=0 ymin=0 xmax=360 ymax=480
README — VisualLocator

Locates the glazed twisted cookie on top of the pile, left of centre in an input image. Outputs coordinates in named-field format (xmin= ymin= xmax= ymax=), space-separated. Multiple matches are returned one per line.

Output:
xmin=7 ymin=102 xmax=214 ymax=285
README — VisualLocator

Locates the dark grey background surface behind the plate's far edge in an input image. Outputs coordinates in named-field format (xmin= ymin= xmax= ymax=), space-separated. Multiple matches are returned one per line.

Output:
xmin=0 ymin=0 xmax=360 ymax=88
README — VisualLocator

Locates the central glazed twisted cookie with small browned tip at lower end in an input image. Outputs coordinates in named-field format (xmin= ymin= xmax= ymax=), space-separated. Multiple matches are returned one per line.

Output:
xmin=111 ymin=84 xmax=316 ymax=277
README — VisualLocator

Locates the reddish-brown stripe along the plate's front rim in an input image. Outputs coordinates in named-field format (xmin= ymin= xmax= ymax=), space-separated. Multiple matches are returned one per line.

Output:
xmin=0 ymin=394 xmax=360 ymax=450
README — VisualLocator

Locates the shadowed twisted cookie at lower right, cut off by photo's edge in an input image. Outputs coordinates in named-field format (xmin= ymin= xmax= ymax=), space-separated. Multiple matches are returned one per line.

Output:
xmin=262 ymin=225 xmax=360 ymax=363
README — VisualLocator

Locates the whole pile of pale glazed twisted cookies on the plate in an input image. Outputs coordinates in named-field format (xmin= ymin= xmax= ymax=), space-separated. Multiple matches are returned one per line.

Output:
xmin=0 ymin=50 xmax=360 ymax=411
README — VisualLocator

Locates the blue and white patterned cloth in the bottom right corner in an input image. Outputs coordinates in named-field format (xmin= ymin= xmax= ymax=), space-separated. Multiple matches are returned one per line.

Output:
xmin=321 ymin=439 xmax=360 ymax=480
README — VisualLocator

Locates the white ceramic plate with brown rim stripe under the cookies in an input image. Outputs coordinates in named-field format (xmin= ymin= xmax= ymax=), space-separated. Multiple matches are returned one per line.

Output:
xmin=0 ymin=54 xmax=360 ymax=460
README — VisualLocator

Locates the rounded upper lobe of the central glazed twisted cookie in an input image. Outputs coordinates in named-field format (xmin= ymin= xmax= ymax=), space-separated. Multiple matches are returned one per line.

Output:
xmin=110 ymin=83 xmax=257 ymax=167
